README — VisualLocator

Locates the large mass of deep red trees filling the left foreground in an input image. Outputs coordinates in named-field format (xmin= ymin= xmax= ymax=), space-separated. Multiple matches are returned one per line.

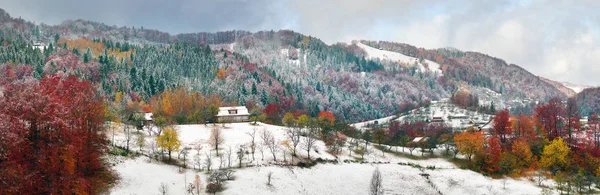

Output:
xmin=0 ymin=76 xmax=107 ymax=194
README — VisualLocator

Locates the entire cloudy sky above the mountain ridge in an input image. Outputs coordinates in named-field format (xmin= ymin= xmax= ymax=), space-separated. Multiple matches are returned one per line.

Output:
xmin=0 ymin=0 xmax=600 ymax=86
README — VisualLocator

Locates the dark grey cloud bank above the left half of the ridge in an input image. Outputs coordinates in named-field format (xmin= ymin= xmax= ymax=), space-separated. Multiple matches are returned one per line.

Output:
xmin=1 ymin=0 xmax=282 ymax=33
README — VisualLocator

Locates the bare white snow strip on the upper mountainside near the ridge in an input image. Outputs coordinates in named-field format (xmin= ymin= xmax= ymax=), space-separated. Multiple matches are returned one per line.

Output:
xmin=356 ymin=42 xmax=442 ymax=75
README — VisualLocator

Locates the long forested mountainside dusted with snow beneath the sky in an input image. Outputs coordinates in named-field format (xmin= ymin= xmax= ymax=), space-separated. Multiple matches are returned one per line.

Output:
xmin=0 ymin=10 xmax=567 ymax=122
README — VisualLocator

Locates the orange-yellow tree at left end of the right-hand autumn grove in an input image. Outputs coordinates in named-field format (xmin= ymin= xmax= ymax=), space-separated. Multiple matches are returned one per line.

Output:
xmin=454 ymin=131 xmax=484 ymax=161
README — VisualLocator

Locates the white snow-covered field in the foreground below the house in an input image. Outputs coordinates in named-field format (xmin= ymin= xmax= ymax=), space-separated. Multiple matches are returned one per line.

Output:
xmin=111 ymin=123 xmax=552 ymax=194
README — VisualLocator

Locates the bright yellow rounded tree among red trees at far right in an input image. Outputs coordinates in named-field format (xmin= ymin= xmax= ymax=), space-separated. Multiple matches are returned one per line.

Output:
xmin=540 ymin=137 xmax=571 ymax=169
